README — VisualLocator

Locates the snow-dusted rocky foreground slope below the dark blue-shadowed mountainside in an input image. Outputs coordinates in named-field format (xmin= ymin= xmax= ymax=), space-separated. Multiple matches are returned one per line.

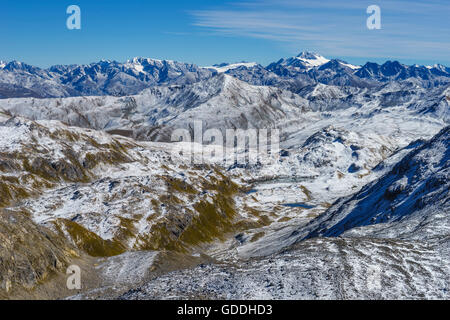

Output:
xmin=117 ymin=239 xmax=450 ymax=300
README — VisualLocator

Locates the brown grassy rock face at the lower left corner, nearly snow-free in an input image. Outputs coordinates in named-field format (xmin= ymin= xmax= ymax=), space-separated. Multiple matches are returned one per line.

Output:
xmin=0 ymin=210 xmax=78 ymax=298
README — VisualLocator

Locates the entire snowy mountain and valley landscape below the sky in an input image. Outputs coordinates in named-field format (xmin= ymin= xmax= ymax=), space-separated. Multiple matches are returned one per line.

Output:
xmin=0 ymin=53 xmax=450 ymax=300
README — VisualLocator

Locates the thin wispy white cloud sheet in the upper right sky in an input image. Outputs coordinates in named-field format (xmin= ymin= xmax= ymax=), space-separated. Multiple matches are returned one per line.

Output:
xmin=191 ymin=0 xmax=450 ymax=61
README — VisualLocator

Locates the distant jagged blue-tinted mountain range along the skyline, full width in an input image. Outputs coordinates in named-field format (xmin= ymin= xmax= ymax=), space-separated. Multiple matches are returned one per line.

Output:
xmin=0 ymin=52 xmax=450 ymax=98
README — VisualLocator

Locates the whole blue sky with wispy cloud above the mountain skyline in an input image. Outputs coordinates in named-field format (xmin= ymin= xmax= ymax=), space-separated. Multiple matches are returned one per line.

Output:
xmin=0 ymin=0 xmax=450 ymax=67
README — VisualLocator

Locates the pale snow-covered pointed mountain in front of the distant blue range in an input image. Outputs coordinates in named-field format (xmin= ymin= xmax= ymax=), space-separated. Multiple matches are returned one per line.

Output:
xmin=0 ymin=74 xmax=306 ymax=141
